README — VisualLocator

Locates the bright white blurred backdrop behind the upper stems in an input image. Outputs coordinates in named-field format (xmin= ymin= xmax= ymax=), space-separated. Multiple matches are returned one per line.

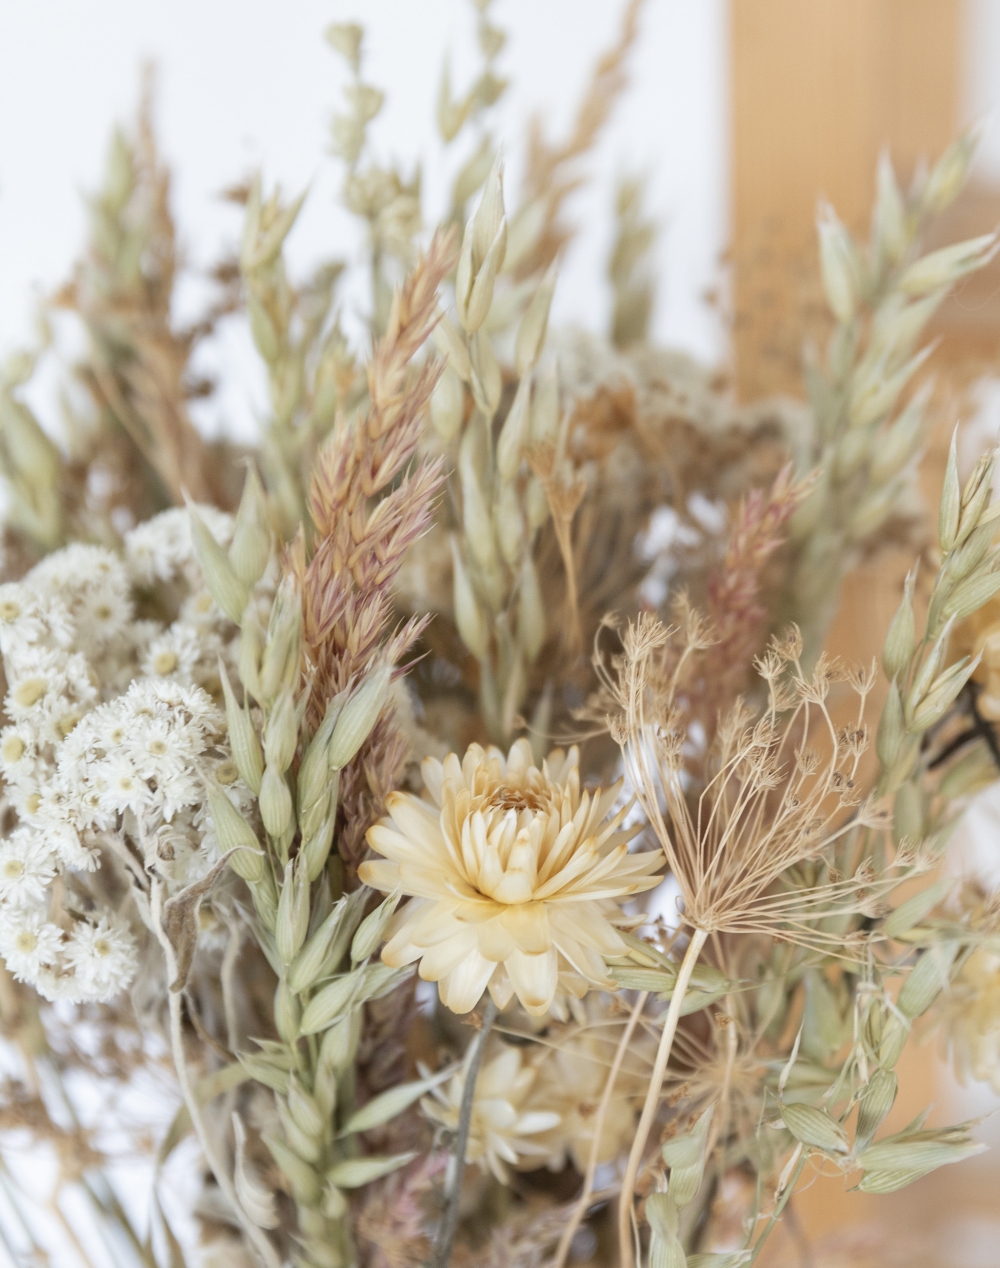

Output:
xmin=0 ymin=0 xmax=726 ymax=446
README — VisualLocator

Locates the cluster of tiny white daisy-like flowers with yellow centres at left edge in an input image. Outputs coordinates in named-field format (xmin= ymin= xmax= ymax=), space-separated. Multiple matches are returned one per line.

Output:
xmin=0 ymin=507 xmax=240 ymax=1002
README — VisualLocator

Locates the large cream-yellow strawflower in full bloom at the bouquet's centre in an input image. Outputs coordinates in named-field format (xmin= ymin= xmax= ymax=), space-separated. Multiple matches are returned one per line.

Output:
xmin=359 ymin=739 xmax=663 ymax=1014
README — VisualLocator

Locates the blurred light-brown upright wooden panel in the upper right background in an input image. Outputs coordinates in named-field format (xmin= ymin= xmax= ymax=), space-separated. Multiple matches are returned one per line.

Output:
xmin=730 ymin=0 xmax=961 ymax=399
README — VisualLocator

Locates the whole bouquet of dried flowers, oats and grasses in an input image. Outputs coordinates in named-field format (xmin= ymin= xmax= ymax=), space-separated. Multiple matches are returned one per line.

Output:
xmin=0 ymin=0 xmax=1000 ymax=1268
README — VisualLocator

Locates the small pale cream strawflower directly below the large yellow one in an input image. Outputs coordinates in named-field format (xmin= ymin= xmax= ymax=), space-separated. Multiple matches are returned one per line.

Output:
xmin=421 ymin=1046 xmax=559 ymax=1184
